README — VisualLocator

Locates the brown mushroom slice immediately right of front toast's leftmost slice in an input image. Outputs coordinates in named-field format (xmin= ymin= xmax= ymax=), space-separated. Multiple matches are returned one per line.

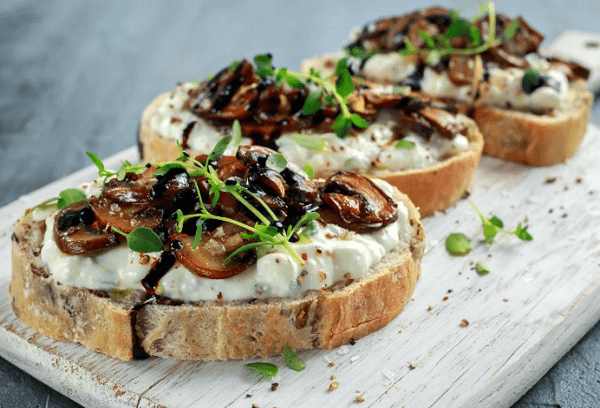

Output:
xmin=91 ymin=199 xmax=163 ymax=234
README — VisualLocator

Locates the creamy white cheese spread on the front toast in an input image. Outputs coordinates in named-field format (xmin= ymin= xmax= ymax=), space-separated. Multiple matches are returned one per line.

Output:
xmin=41 ymin=180 xmax=413 ymax=301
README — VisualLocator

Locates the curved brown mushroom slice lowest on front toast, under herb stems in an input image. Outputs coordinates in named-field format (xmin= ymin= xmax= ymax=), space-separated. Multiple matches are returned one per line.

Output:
xmin=172 ymin=228 xmax=256 ymax=279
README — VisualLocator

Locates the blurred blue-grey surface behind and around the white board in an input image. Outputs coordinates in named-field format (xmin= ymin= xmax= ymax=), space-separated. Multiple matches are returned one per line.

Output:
xmin=0 ymin=0 xmax=600 ymax=408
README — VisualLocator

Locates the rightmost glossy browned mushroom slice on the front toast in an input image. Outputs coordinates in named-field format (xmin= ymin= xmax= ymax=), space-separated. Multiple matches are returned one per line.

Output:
xmin=321 ymin=172 xmax=398 ymax=232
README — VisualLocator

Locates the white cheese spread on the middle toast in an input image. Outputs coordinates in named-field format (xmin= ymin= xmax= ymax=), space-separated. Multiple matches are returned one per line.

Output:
xmin=148 ymin=83 xmax=469 ymax=174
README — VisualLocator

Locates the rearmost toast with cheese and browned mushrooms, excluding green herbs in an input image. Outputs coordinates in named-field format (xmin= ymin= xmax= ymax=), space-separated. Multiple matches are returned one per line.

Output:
xmin=301 ymin=7 xmax=592 ymax=166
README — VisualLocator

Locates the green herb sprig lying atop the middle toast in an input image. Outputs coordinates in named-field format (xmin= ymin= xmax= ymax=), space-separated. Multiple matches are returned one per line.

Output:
xmin=254 ymin=54 xmax=369 ymax=138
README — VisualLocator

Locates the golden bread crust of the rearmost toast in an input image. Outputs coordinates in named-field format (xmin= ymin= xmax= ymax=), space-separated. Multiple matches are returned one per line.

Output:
xmin=472 ymin=80 xmax=593 ymax=166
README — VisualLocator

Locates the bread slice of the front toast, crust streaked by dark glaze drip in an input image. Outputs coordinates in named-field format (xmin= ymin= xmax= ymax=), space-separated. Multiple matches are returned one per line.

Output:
xmin=9 ymin=191 xmax=425 ymax=360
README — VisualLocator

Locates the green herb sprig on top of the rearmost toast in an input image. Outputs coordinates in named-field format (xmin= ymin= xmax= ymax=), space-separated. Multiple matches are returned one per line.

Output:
xmin=400 ymin=1 xmax=519 ymax=65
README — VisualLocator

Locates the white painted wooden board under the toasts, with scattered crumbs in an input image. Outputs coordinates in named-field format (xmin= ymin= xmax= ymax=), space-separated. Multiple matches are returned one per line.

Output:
xmin=0 ymin=125 xmax=600 ymax=408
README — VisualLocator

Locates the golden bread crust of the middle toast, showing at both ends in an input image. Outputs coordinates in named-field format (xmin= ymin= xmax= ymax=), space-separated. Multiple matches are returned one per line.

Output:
xmin=138 ymin=93 xmax=483 ymax=217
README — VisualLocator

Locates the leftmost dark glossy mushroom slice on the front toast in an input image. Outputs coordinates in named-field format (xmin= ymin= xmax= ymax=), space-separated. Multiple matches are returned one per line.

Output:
xmin=53 ymin=201 xmax=119 ymax=255
